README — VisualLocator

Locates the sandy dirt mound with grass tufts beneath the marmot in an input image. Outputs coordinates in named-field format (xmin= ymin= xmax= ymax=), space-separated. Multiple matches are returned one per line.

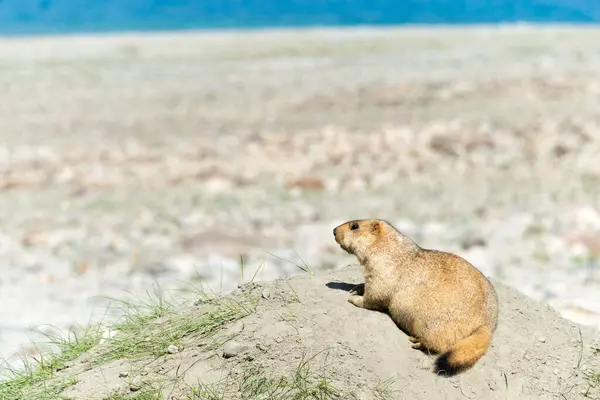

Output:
xmin=31 ymin=267 xmax=600 ymax=400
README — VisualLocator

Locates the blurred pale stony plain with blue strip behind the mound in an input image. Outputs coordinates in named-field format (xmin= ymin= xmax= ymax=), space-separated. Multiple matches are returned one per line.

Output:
xmin=0 ymin=0 xmax=600 ymax=368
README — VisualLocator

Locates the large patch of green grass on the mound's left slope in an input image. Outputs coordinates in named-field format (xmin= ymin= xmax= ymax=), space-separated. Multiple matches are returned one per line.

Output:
xmin=0 ymin=274 xmax=258 ymax=400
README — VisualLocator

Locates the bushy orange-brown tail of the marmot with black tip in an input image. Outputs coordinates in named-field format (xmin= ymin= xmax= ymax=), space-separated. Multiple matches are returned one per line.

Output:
xmin=436 ymin=326 xmax=492 ymax=376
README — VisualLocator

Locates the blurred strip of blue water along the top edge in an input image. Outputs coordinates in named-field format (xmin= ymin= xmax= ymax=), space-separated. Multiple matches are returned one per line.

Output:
xmin=0 ymin=0 xmax=600 ymax=34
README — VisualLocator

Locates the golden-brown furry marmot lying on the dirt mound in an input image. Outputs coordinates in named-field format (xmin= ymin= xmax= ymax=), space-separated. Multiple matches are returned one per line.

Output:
xmin=333 ymin=219 xmax=498 ymax=375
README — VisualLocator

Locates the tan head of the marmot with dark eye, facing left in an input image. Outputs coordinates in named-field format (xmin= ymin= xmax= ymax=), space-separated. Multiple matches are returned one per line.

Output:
xmin=333 ymin=219 xmax=388 ymax=259
